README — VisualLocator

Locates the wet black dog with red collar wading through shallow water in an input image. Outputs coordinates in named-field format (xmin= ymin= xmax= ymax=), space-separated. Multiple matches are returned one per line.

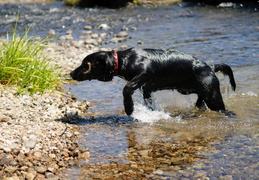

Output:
xmin=70 ymin=48 xmax=236 ymax=115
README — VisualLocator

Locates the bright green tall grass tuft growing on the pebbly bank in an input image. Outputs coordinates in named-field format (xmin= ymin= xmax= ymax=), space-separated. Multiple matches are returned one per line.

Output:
xmin=0 ymin=28 xmax=60 ymax=94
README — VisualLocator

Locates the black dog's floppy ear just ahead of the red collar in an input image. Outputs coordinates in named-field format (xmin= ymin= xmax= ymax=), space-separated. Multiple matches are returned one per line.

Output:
xmin=98 ymin=52 xmax=114 ymax=81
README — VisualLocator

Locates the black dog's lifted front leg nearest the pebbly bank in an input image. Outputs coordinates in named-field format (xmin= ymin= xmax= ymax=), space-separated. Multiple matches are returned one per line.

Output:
xmin=123 ymin=73 xmax=149 ymax=116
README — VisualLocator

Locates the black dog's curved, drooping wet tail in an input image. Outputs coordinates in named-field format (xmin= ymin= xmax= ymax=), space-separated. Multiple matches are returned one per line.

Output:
xmin=212 ymin=63 xmax=236 ymax=91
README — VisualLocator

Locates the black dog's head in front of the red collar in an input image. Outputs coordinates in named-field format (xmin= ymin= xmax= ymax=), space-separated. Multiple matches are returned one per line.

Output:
xmin=70 ymin=51 xmax=115 ymax=81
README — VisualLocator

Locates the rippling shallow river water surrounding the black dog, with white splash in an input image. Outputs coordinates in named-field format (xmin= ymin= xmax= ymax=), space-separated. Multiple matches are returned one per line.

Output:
xmin=0 ymin=2 xmax=259 ymax=179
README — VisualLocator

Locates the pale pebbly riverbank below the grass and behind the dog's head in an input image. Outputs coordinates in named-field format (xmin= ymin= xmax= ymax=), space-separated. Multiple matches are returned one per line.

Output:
xmin=0 ymin=26 xmax=127 ymax=180
